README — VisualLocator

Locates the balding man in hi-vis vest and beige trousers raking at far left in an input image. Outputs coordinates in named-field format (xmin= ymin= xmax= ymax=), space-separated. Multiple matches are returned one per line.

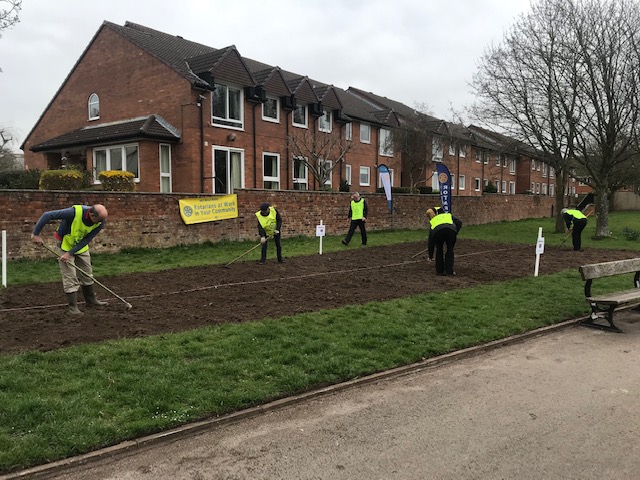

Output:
xmin=31 ymin=204 xmax=109 ymax=315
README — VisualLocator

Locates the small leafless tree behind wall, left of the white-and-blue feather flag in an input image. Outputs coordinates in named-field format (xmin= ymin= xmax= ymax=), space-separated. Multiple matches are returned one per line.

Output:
xmin=287 ymin=129 xmax=353 ymax=190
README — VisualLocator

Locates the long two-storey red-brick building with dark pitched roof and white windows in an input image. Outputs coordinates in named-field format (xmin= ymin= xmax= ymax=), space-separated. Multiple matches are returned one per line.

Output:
xmin=21 ymin=22 xmax=553 ymax=200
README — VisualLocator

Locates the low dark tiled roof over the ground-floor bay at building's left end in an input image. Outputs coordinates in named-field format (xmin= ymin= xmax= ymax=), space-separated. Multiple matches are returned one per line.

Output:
xmin=31 ymin=115 xmax=180 ymax=152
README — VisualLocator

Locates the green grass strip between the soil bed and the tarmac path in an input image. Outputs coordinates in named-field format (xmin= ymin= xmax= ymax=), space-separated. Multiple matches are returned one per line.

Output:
xmin=0 ymin=270 xmax=630 ymax=472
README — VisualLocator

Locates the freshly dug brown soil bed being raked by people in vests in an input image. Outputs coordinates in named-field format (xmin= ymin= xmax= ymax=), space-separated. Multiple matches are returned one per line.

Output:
xmin=0 ymin=239 xmax=638 ymax=354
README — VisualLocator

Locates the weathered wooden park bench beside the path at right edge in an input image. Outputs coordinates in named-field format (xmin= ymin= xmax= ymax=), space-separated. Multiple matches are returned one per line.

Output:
xmin=579 ymin=258 xmax=640 ymax=333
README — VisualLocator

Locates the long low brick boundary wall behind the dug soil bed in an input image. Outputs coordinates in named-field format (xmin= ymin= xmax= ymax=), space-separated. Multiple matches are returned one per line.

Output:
xmin=0 ymin=189 xmax=554 ymax=260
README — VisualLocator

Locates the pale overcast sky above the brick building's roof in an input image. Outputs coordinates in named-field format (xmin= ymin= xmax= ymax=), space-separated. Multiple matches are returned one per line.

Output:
xmin=0 ymin=0 xmax=530 ymax=150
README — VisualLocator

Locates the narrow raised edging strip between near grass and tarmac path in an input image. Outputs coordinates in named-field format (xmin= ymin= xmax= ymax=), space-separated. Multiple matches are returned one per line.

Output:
xmin=0 ymin=316 xmax=592 ymax=480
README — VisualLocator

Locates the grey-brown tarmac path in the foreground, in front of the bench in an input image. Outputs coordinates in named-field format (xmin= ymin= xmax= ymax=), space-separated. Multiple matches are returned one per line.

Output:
xmin=12 ymin=312 xmax=640 ymax=480
